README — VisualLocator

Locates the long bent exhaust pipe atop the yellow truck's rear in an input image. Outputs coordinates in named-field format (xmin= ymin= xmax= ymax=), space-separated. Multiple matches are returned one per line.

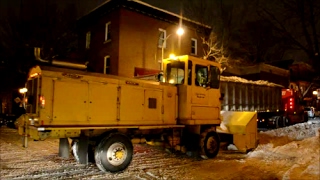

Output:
xmin=34 ymin=47 xmax=88 ymax=70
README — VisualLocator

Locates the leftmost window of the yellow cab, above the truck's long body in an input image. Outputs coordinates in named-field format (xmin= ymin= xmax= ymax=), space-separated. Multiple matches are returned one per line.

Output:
xmin=165 ymin=61 xmax=185 ymax=84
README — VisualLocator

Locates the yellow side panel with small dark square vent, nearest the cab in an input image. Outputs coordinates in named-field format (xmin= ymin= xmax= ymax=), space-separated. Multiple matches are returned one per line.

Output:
xmin=143 ymin=89 xmax=163 ymax=124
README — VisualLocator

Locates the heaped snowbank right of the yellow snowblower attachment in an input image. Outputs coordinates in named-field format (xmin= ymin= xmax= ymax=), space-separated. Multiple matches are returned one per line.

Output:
xmin=247 ymin=122 xmax=320 ymax=179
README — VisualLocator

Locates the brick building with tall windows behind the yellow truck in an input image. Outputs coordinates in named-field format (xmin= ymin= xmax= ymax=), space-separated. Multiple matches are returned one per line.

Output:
xmin=78 ymin=0 xmax=211 ymax=77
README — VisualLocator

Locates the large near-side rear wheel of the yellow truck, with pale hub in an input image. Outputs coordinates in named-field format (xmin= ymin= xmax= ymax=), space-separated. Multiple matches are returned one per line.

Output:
xmin=95 ymin=133 xmax=133 ymax=172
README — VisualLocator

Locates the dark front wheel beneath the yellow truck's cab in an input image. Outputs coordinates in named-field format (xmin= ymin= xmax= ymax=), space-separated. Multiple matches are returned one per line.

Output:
xmin=200 ymin=131 xmax=220 ymax=159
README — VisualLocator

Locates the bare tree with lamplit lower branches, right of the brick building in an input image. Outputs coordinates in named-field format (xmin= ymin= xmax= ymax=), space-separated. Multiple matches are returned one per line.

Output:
xmin=184 ymin=0 xmax=253 ymax=66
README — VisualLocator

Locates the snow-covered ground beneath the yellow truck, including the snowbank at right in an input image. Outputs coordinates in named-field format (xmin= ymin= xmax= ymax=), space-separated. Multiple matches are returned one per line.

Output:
xmin=0 ymin=123 xmax=320 ymax=180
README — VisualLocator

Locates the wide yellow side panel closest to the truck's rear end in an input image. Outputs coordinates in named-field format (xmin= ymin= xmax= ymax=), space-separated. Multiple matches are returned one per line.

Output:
xmin=51 ymin=81 xmax=88 ymax=125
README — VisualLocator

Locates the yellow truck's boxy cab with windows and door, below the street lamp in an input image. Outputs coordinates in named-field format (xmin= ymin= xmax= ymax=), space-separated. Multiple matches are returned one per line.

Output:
xmin=162 ymin=55 xmax=221 ymax=125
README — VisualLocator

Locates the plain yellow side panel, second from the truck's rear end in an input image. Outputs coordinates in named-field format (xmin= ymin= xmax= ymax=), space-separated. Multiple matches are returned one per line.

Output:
xmin=88 ymin=83 xmax=118 ymax=125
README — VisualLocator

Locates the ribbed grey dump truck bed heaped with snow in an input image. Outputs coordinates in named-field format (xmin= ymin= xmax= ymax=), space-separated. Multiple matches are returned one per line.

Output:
xmin=220 ymin=77 xmax=283 ymax=112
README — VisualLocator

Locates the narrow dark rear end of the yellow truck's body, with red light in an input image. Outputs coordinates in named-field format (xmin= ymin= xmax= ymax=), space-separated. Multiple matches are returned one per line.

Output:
xmin=25 ymin=78 xmax=39 ymax=114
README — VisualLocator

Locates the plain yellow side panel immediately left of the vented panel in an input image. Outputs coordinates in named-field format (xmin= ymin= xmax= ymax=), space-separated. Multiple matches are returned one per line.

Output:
xmin=119 ymin=85 xmax=145 ymax=124
